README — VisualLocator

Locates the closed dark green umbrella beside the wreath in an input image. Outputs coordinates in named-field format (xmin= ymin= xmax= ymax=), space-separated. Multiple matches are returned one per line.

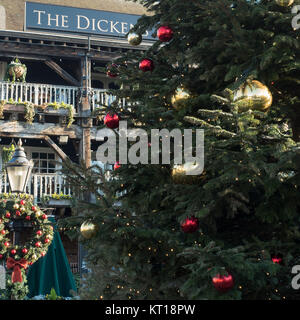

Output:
xmin=27 ymin=217 xmax=76 ymax=298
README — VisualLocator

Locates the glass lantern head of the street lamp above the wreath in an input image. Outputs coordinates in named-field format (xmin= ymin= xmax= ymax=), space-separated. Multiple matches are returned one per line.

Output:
xmin=5 ymin=139 xmax=33 ymax=193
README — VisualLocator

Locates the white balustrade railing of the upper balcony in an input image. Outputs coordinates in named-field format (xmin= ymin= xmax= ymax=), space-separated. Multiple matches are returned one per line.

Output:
xmin=0 ymin=81 xmax=125 ymax=113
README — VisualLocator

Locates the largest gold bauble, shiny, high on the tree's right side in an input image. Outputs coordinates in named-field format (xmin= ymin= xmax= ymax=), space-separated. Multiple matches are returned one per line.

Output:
xmin=233 ymin=80 xmax=273 ymax=112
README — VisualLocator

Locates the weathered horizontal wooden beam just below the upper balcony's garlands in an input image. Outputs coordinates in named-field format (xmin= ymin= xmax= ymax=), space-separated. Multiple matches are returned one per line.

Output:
xmin=0 ymin=120 xmax=82 ymax=139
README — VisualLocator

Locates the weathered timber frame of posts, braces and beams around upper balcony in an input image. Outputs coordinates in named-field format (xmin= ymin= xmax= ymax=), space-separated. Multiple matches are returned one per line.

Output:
xmin=0 ymin=30 xmax=150 ymax=167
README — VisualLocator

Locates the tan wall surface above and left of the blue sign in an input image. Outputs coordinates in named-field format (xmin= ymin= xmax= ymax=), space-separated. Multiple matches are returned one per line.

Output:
xmin=0 ymin=0 xmax=146 ymax=31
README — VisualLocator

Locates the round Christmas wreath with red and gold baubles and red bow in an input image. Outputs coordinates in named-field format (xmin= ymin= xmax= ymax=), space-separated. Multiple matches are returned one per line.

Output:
xmin=0 ymin=194 xmax=53 ymax=298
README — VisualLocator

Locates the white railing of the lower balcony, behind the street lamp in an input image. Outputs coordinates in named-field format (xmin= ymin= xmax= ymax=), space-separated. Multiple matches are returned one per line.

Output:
xmin=0 ymin=173 xmax=72 ymax=203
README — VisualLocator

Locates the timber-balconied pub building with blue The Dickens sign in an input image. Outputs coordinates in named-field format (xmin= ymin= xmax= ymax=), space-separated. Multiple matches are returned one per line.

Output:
xmin=0 ymin=0 xmax=150 ymax=272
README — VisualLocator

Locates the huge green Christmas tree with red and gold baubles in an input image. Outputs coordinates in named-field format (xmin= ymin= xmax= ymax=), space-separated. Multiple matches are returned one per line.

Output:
xmin=61 ymin=0 xmax=300 ymax=300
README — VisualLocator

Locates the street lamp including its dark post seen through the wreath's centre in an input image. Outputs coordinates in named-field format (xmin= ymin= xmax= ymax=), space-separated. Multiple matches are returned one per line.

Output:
xmin=5 ymin=139 xmax=33 ymax=244
